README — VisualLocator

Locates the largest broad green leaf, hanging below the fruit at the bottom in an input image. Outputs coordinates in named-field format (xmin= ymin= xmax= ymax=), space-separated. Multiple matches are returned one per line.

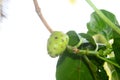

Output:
xmin=56 ymin=51 xmax=94 ymax=80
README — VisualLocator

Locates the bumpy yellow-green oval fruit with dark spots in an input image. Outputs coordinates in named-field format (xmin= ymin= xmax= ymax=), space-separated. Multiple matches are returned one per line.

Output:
xmin=47 ymin=31 xmax=69 ymax=58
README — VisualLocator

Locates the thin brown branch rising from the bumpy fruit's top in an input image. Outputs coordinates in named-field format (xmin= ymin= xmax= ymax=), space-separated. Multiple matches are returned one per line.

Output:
xmin=33 ymin=0 xmax=53 ymax=33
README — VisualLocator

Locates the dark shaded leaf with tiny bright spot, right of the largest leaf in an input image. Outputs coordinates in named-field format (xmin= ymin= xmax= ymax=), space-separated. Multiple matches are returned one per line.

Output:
xmin=85 ymin=56 xmax=108 ymax=80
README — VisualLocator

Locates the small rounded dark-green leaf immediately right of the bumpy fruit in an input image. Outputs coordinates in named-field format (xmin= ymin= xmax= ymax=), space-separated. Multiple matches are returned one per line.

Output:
xmin=67 ymin=31 xmax=80 ymax=46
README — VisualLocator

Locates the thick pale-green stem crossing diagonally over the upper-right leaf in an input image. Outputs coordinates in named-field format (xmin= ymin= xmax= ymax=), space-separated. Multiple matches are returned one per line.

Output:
xmin=86 ymin=0 xmax=120 ymax=34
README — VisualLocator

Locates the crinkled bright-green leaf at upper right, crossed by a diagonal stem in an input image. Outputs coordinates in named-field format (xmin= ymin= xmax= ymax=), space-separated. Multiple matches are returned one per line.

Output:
xmin=87 ymin=10 xmax=118 ymax=40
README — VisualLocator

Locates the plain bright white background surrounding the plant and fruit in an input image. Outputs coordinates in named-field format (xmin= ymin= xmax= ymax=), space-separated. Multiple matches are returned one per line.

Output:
xmin=0 ymin=0 xmax=120 ymax=80
